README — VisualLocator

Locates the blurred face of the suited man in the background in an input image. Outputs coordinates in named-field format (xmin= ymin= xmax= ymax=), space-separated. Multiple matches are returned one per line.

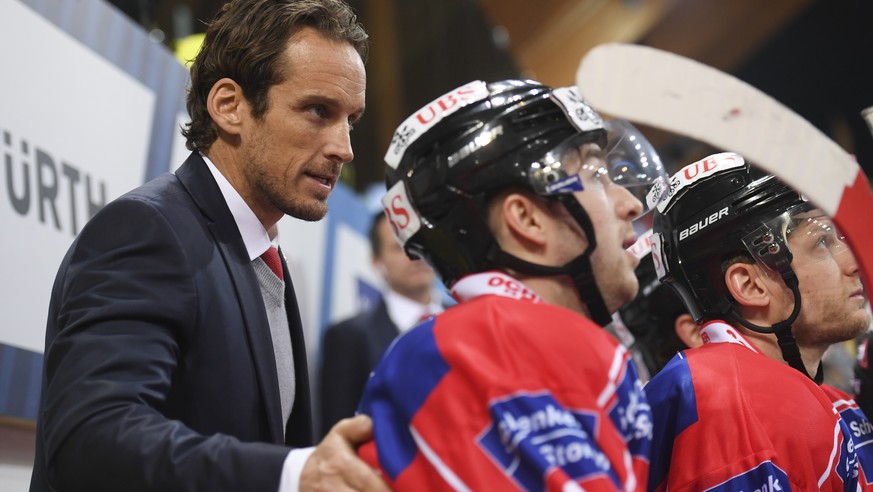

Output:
xmin=373 ymin=217 xmax=436 ymax=302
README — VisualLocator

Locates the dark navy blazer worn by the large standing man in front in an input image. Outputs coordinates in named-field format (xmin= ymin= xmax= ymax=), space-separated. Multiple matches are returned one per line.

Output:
xmin=31 ymin=153 xmax=313 ymax=492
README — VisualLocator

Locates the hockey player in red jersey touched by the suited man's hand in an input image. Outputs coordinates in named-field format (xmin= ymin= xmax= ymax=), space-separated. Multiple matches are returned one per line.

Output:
xmin=360 ymin=80 xmax=666 ymax=491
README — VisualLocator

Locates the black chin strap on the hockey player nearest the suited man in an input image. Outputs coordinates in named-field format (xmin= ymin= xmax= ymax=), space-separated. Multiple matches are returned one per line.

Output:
xmin=486 ymin=195 xmax=612 ymax=326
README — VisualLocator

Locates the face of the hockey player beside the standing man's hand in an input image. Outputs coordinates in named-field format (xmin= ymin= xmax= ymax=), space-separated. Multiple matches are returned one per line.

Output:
xmin=565 ymin=143 xmax=642 ymax=312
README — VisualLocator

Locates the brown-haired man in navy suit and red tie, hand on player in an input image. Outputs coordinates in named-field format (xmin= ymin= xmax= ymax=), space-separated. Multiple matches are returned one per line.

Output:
xmin=31 ymin=0 xmax=385 ymax=492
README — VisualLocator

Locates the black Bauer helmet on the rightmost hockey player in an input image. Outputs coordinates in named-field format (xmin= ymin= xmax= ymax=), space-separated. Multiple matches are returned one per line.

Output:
xmin=651 ymin=152 xmax=846 ymax=380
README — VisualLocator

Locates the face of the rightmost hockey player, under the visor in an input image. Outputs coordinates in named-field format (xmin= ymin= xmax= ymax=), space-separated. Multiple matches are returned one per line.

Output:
xmin=785 ymin=210 xmax=870 ymax=345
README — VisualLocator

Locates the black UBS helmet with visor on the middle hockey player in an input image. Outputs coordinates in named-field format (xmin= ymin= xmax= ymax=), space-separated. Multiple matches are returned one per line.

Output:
xmin=383 ymin=80 xmax=666 ymax=324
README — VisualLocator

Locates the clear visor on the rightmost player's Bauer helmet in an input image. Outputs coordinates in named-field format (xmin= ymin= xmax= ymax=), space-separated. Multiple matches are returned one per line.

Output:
xmin=743 ymin=204 xmax=851 ymax=273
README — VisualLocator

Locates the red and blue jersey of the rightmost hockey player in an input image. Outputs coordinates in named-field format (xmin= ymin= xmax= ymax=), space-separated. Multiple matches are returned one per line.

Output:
xmin=645 ymin=322 xmax=858 ymax=492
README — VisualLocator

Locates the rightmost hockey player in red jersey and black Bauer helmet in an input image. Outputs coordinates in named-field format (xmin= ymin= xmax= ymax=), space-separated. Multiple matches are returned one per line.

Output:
xmin=646 ymin=153 xmax=873 ymax=491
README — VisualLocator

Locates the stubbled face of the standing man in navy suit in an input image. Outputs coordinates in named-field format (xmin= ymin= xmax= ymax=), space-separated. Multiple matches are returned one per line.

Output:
xmin=238 ymin=28 xmax=366 ymax=221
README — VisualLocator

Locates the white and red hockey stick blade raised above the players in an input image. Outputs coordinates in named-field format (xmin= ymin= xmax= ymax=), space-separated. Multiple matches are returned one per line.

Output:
xmin=576 ymin=43 xmax=873 ymax=292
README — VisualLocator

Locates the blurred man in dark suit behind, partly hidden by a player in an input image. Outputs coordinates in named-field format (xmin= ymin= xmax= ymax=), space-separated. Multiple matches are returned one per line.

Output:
xmin=319 ymin=212 xmax=443 ymax=435
